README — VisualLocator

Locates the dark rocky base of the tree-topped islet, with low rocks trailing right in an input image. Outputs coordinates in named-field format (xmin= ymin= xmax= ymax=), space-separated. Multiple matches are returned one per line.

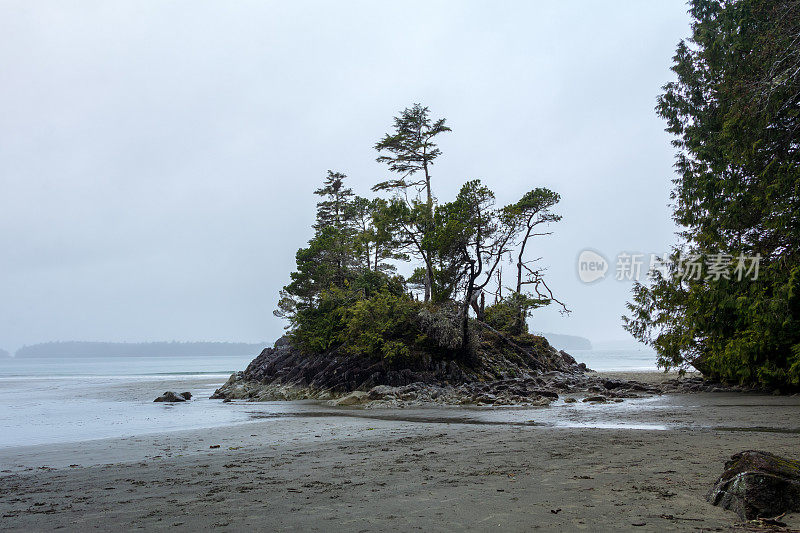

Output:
xmin=212 ymin=330 xmax=732 ymax=407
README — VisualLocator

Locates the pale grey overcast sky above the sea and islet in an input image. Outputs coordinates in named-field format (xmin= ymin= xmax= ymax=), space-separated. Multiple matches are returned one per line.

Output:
xmin=0 ymin=0 xmax=689 ymax=351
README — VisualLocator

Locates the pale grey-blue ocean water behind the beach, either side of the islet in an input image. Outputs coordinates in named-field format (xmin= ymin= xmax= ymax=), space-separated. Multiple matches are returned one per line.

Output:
xmin=0 ymin=350 xmax=656 ymax=448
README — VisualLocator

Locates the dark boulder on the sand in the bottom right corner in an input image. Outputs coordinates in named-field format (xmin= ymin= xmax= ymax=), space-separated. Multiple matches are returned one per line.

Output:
xmin=706 ymin=450 xmax=800 ymax=520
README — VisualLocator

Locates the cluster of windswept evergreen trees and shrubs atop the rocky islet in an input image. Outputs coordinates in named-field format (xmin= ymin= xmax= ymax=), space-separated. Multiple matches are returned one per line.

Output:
xmin=275 ymin=104 xmax=561 ymax=364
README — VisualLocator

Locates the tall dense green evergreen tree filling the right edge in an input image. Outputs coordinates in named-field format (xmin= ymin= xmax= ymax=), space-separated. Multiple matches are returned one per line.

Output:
xmin=624 ymin=0 xmax=800 ymax=388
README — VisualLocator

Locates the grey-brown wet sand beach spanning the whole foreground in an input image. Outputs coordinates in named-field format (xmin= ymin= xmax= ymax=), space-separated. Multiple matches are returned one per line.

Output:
xmin=0 ymin=376 xmax=800 ymax=531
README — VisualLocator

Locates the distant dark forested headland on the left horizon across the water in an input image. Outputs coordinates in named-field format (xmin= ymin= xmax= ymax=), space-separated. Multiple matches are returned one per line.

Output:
xmin=13 ymin=341 xmax=267 ymax=357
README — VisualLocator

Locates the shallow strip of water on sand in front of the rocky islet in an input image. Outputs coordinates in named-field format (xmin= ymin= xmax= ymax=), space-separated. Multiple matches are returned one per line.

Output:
xmin=245 ymin=393 xmax=800 ymax=434
